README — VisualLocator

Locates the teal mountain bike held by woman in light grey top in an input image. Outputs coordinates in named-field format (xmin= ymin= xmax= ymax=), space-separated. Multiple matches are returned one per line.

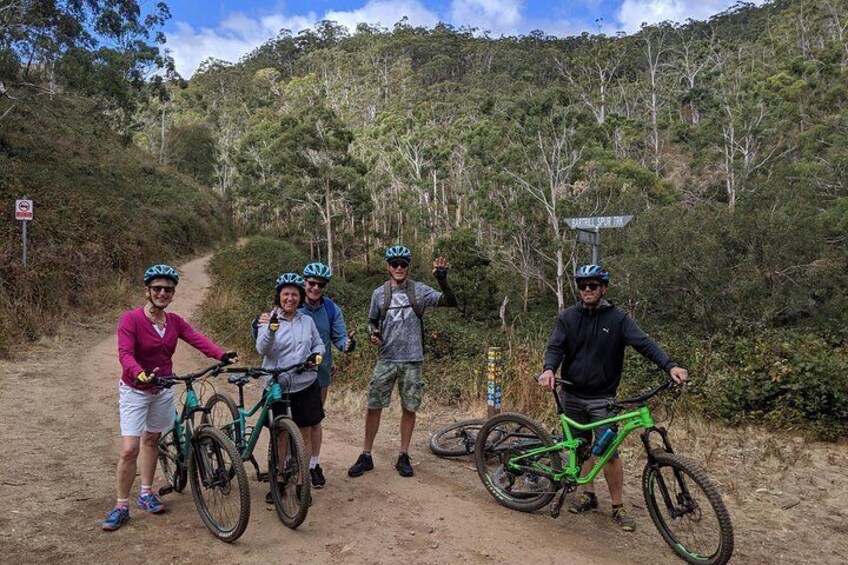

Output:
xmin=203 ymin=355 xmax=321 ymax=528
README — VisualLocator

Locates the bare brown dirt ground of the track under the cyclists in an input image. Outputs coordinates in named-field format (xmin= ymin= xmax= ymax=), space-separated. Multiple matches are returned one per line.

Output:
xmin=0 ymin=253 xmax=848 ymax=564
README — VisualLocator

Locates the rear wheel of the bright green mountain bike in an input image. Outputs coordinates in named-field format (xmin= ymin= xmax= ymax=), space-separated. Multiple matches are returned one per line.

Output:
xmin=474 ymin=412 xmax=562 ymax=512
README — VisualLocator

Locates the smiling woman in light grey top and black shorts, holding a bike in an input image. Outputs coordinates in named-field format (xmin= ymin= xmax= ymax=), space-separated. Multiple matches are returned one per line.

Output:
xmin=256 ymin=273 xmax=324 ymax=502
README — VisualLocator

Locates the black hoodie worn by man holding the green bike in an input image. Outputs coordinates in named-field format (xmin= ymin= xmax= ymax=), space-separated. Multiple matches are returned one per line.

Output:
xmin=544 ymin=300 xmax=677 ymax=398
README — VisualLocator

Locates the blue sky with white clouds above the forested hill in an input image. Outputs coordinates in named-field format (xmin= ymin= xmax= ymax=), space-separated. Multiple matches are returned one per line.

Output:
xmin=161 ymin=0 xmax=764 ymax=78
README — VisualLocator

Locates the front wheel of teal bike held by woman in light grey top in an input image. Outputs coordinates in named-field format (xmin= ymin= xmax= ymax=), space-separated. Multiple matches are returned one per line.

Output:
xmin=268 ymin=416 xmax=312 ymax=529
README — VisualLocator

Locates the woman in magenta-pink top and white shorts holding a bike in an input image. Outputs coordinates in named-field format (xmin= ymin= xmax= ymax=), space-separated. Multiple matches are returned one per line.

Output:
xmin=101 ymin=265 xmax=238 ymax=531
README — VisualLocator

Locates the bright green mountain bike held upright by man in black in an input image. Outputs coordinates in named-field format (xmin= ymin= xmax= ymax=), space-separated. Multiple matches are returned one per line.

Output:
xmin=474 ymin=379 xmax=733 ymax=565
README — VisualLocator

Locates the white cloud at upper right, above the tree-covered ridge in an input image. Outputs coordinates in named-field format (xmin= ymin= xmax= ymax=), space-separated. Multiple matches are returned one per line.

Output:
xmin=616 ymin=0 xmax=764 ymax=33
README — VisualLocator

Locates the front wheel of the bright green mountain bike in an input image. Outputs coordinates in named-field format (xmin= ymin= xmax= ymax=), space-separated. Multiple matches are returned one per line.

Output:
xmin=642 ymin=452 xmax=733 ymax=565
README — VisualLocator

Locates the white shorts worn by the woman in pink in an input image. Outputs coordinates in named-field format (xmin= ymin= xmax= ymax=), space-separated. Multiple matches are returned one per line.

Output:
xmin=118 ymin=381 xmax=177 ymax=437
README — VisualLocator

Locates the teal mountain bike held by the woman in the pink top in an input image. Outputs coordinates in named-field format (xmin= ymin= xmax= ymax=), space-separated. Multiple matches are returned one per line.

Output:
xmin=151 ymin=365 xmax=250 ymax=543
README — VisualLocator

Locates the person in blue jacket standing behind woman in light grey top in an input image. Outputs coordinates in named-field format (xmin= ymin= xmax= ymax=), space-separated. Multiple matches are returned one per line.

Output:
xmin=259 ymin=262 xmax=356 ymax=488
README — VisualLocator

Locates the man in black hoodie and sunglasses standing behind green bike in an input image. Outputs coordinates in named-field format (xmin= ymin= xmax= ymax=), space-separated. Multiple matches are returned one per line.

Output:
xmin=538 ymin=265 xmax=689 ymax=531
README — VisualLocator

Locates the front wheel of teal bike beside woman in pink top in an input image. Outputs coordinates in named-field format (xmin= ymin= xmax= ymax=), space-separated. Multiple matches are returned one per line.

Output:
xmin=188 ymin=426 xmax=250 ymax=543
